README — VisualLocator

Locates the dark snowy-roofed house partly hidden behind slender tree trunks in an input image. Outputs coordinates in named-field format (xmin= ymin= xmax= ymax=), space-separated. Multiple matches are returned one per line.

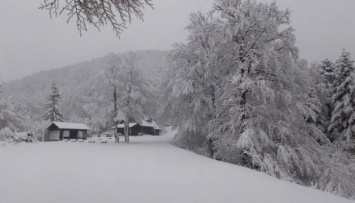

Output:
xmin=117 ymin=120 xmax=160 ymax=135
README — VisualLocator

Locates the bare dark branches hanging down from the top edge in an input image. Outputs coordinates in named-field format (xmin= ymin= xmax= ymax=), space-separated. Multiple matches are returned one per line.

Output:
xmin=39 ymin=0 xmax=153 ymax=37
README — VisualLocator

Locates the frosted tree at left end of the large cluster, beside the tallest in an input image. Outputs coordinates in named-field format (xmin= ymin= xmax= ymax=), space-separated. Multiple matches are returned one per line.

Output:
xmin=163 ymin=13 xmax=226 ymax=153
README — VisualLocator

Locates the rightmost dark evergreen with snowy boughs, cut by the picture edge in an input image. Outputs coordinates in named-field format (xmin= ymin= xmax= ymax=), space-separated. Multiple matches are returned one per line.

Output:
xmin=328 ymin=50 xmax=355 ymax=141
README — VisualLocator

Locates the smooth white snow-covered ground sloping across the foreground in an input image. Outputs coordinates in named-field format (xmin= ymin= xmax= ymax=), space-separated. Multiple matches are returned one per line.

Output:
xmin=0 ymin=131 xmax=354 ymax=203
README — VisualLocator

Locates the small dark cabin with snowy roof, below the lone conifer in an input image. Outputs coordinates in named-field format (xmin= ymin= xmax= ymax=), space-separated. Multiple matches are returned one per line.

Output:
xmin=44 ymin=122 xmax=89 ymax=141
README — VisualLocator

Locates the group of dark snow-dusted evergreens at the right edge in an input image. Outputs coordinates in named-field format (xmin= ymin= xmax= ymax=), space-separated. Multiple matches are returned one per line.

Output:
xmin=318 ymin=50 xmax=355 ymax=142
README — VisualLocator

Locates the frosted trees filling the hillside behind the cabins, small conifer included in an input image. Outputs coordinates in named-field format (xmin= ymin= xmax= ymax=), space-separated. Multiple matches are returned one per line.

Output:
xmin=0 ymin=51 xmax=167 ymax=141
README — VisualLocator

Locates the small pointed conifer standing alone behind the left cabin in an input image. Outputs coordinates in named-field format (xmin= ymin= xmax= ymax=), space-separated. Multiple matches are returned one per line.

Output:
xmin=43 ymin=82 xmax=64 ymax=122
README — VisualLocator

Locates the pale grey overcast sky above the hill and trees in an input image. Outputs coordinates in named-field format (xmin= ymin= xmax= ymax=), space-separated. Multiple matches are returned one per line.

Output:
xmin=0 ymin=0 xmax=355 ymax=82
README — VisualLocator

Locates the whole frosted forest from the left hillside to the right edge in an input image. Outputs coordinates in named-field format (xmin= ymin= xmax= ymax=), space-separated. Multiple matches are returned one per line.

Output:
xmin=0 ymin=0 xmax=355 ymax=198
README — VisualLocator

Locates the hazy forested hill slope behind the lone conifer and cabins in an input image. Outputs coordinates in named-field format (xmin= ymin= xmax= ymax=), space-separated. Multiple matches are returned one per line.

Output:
xmin=3 ymin=50 xmax=168 ymax=134
